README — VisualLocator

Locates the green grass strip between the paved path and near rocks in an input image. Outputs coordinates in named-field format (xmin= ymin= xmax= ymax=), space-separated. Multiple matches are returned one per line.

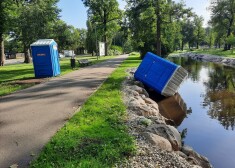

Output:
xmin=31 ymin=52 xmax=140 ymax=168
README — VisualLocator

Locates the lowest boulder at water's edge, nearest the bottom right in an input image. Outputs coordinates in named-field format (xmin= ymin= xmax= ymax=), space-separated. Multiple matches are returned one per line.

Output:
xmin=182 ymin=145 xmax=212 ymax=168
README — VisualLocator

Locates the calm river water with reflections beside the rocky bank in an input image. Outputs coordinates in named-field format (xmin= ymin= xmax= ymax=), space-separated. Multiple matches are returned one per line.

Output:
xmin=153 ymin=57 xmax=235 ymax=168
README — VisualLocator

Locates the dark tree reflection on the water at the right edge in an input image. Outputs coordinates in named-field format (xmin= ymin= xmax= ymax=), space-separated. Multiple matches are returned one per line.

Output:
xmin=204 ymin=65 xmax=235 ymax=130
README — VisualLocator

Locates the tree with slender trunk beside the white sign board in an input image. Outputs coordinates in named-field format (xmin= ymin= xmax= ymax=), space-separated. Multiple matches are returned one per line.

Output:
xmin=82 ymin=0 xmax=122 ymax=55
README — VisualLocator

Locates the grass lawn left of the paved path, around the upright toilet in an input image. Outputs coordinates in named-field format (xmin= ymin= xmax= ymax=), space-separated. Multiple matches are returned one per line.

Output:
xmin=0 ymin=56 xmax=117 ymax=96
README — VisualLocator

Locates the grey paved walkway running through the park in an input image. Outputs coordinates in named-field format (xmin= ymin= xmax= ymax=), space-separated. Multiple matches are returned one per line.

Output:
xmin=0 ymin=55 xmax=127 ymax=168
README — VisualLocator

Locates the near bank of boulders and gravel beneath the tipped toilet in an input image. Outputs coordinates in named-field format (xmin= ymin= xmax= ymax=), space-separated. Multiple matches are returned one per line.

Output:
xmin=117 ymin=69 xmax=212 ymax=168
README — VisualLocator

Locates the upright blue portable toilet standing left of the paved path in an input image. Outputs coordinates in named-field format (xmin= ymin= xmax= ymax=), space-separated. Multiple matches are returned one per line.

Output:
xmin=30 ymin=39 xmax=60 ymax=78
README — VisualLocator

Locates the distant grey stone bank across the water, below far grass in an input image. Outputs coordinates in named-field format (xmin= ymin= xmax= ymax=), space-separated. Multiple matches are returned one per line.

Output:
xmin=180 ymin=52 xmax=235 ymax=67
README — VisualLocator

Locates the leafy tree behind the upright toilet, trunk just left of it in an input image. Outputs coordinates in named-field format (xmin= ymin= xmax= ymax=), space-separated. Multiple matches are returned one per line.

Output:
xmin=18 ymin=0 xmax=60 ymax=63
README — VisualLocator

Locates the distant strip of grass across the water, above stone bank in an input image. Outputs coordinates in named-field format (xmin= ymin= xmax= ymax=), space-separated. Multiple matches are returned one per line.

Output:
xmin=172 ymin=49 xmax=235 ymax=58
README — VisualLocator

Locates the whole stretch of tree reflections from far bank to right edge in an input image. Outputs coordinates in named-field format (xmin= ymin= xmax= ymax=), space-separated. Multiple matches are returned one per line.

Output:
xmin=170 ymin=57 xmax=235 ymax=130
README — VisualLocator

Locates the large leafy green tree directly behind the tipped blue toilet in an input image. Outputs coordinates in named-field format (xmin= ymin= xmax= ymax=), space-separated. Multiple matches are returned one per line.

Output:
xmin=127 ymin=0 xmax=190 ymax=56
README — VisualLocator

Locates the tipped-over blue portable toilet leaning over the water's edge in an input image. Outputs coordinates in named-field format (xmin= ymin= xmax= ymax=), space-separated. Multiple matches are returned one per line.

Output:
xmin=134 ymin=52 xmax=188 ymax=97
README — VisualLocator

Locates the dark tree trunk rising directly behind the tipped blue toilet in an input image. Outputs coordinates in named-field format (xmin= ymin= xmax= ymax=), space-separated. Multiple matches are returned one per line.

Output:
xmin=156 ymin=0 xmax=162 ymax=56
